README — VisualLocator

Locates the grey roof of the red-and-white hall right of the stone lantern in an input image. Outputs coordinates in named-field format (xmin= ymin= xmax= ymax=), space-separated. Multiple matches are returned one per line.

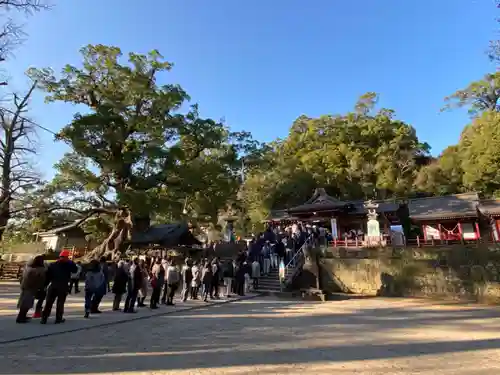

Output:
xmin=408 ymin=193 xmax=479 ymax=220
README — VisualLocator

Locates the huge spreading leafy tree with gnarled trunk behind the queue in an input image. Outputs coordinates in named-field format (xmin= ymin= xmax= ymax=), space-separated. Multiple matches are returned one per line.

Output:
xmin=29 ymin=45 xmax=251 ymax=258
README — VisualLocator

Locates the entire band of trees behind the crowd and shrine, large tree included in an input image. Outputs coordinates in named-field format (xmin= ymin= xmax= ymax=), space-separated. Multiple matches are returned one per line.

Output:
xmin=0 ymin=2 xmax=500 ymax=255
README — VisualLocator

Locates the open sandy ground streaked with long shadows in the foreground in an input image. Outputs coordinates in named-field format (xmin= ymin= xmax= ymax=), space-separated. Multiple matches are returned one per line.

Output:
xmin=0 ymin=298 xmax=500 ymax=375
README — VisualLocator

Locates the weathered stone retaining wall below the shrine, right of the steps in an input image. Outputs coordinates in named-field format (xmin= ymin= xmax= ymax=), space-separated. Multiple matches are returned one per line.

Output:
xmin=320 ymin=248 xmax=500 ymax=303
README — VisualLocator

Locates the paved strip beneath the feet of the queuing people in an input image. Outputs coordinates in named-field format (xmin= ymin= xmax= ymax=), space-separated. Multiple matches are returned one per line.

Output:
xmin=0 ymin=281 xmax=255 ymax=344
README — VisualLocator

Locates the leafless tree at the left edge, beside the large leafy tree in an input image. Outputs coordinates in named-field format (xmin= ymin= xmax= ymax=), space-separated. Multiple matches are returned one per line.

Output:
xmin=0 ymin=82 xmax=40 ymax=240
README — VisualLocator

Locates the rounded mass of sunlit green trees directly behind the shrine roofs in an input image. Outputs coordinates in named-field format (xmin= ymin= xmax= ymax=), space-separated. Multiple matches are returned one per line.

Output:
xmin=242 ymin=93 xmax=429 ymax=226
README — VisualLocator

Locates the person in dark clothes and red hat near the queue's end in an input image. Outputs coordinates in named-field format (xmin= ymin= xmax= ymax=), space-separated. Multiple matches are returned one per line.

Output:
xmin=40 ymin=250 xmax=78 ymax=324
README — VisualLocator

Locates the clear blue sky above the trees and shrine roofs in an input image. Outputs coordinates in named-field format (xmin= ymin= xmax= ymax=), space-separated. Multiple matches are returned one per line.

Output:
xmin=1 ymin=0 xmax=498 ymax=176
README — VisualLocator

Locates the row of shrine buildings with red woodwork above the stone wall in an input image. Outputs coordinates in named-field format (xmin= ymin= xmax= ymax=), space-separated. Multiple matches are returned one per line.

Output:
xmin=269 ymin=189 xmax=500 ymax=246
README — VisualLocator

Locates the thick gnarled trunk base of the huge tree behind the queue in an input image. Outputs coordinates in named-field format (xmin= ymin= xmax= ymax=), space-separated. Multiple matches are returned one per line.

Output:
xmin=83 ymin=208 xmax=132 ymax=261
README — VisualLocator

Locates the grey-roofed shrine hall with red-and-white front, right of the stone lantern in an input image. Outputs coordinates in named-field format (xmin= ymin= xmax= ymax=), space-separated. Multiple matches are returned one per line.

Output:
xmin=408 ymin=193 xmax=481 ymax=242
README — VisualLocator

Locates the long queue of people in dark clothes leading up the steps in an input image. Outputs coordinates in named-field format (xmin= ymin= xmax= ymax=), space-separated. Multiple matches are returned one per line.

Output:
xmin=16 ymin=224 xmax=320 ymax=324
